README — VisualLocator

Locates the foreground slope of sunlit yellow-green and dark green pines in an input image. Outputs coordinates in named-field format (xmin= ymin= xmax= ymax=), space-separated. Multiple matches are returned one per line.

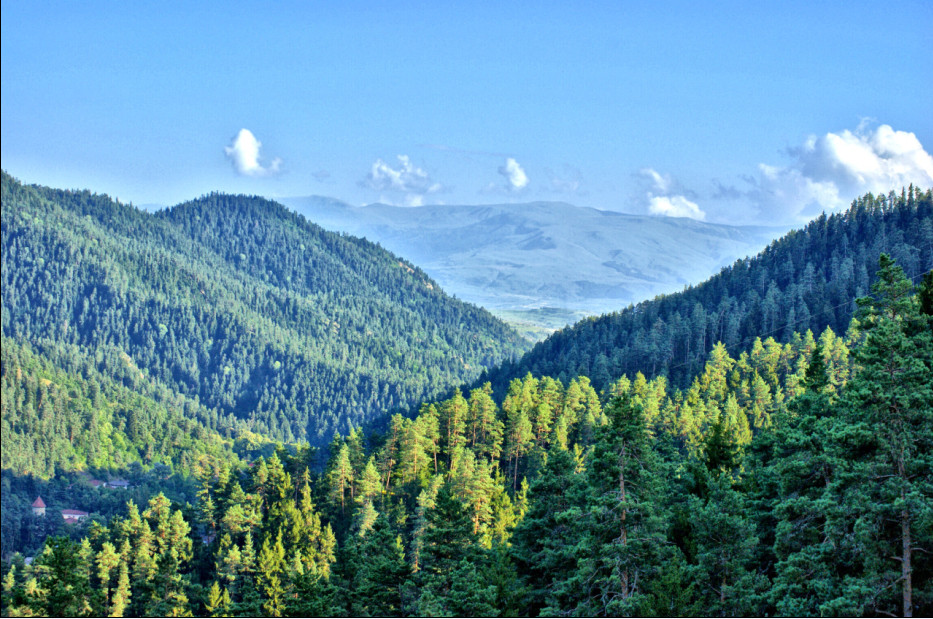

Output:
xmin=3 ymin=256 xmax=933 ymax=617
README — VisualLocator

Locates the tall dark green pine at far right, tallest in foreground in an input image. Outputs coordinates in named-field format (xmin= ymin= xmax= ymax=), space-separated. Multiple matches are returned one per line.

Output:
xmin=831 ymin=254 xmax=933 ymax=616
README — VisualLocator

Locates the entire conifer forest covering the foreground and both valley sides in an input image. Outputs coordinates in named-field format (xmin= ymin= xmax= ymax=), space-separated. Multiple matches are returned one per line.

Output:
xmin=0 ymin=176 xmax=933 ymax=617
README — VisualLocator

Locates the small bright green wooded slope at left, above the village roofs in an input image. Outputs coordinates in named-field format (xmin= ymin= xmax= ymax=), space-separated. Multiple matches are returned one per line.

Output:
xmin=0 ymin=337 xmax=261 ymax=479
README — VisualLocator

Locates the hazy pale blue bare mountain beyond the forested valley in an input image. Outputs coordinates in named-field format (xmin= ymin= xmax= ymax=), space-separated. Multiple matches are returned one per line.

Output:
xmin=282 ymin=197 xmax=778 ymax=326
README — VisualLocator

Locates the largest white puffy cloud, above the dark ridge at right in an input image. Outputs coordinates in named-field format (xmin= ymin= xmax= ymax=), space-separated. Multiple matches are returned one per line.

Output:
xmin=746 ymin=123 xmax=933 ymax=223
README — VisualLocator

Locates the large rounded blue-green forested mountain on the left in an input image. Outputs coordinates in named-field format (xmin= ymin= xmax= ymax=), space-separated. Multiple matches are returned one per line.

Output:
xmin=2 ymin=173 xmax=525 ymax=448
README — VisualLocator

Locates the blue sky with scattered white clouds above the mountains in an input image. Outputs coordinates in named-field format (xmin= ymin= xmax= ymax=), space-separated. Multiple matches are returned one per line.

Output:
xmin=0 ymin=0 xmax=933 ymax=223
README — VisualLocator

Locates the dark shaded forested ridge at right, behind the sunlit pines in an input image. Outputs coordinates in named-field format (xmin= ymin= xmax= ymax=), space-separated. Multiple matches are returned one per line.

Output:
xmin=488 ymin=186 xmax=933 ymax=391
